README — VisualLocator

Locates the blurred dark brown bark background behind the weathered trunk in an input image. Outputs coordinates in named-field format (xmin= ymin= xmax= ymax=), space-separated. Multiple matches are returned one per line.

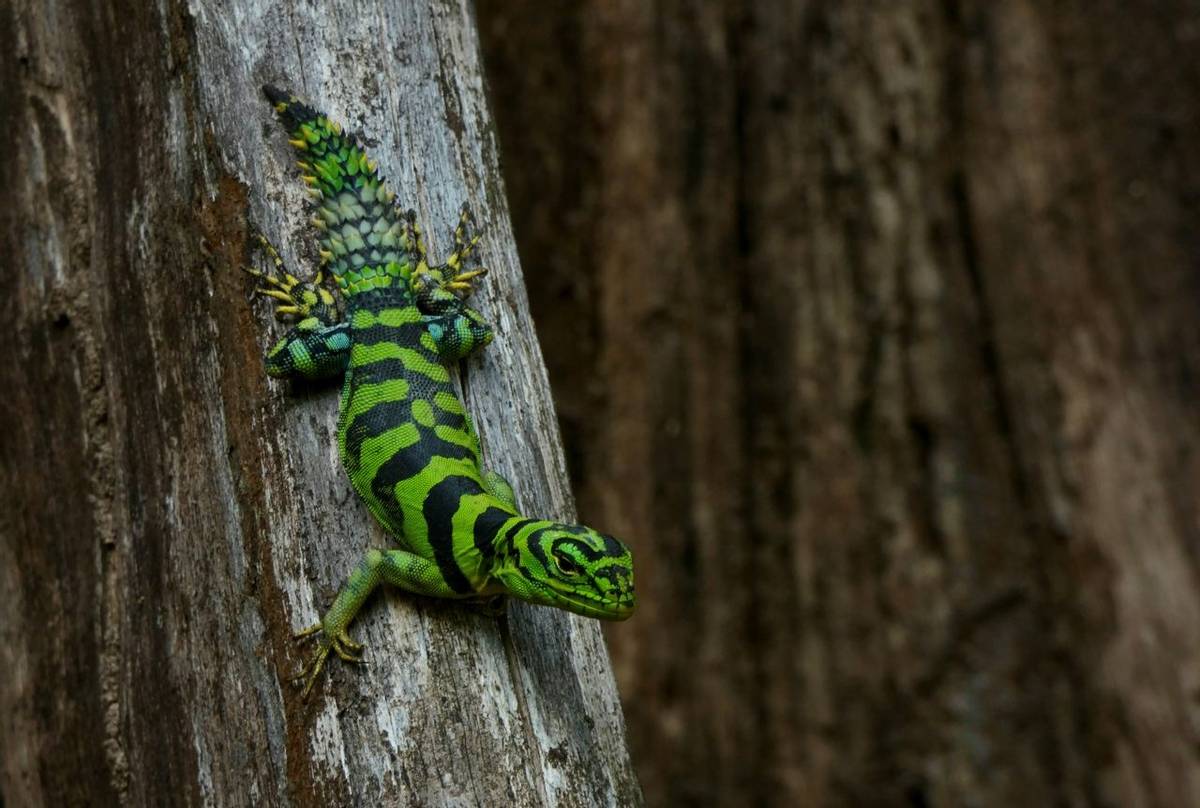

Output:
xmin=479 ymin=0 xmax=1200 ymax=807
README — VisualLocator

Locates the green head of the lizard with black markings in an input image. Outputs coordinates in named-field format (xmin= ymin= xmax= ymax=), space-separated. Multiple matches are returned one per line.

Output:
xmin=493 ymin=521 xmax=635 ymax=620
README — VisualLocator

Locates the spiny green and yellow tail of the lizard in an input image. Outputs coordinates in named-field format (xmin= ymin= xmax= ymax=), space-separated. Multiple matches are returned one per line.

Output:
xmin=263 ymin=85 xmax=415 ymax=295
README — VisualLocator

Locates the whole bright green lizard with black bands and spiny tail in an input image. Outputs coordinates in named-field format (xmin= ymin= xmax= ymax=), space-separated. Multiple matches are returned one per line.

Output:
xmin=251 ymin=86 xmax=634 ymax=695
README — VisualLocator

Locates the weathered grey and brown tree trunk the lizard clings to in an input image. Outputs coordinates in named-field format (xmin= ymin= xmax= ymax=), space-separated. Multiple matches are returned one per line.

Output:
xmin=0 ymin=0 xmax=640 ymax=806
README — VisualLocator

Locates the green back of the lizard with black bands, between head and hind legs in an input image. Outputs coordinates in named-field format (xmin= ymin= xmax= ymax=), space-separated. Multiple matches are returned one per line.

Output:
xmin=338 ymin=289 xmax=514 ymax=593
